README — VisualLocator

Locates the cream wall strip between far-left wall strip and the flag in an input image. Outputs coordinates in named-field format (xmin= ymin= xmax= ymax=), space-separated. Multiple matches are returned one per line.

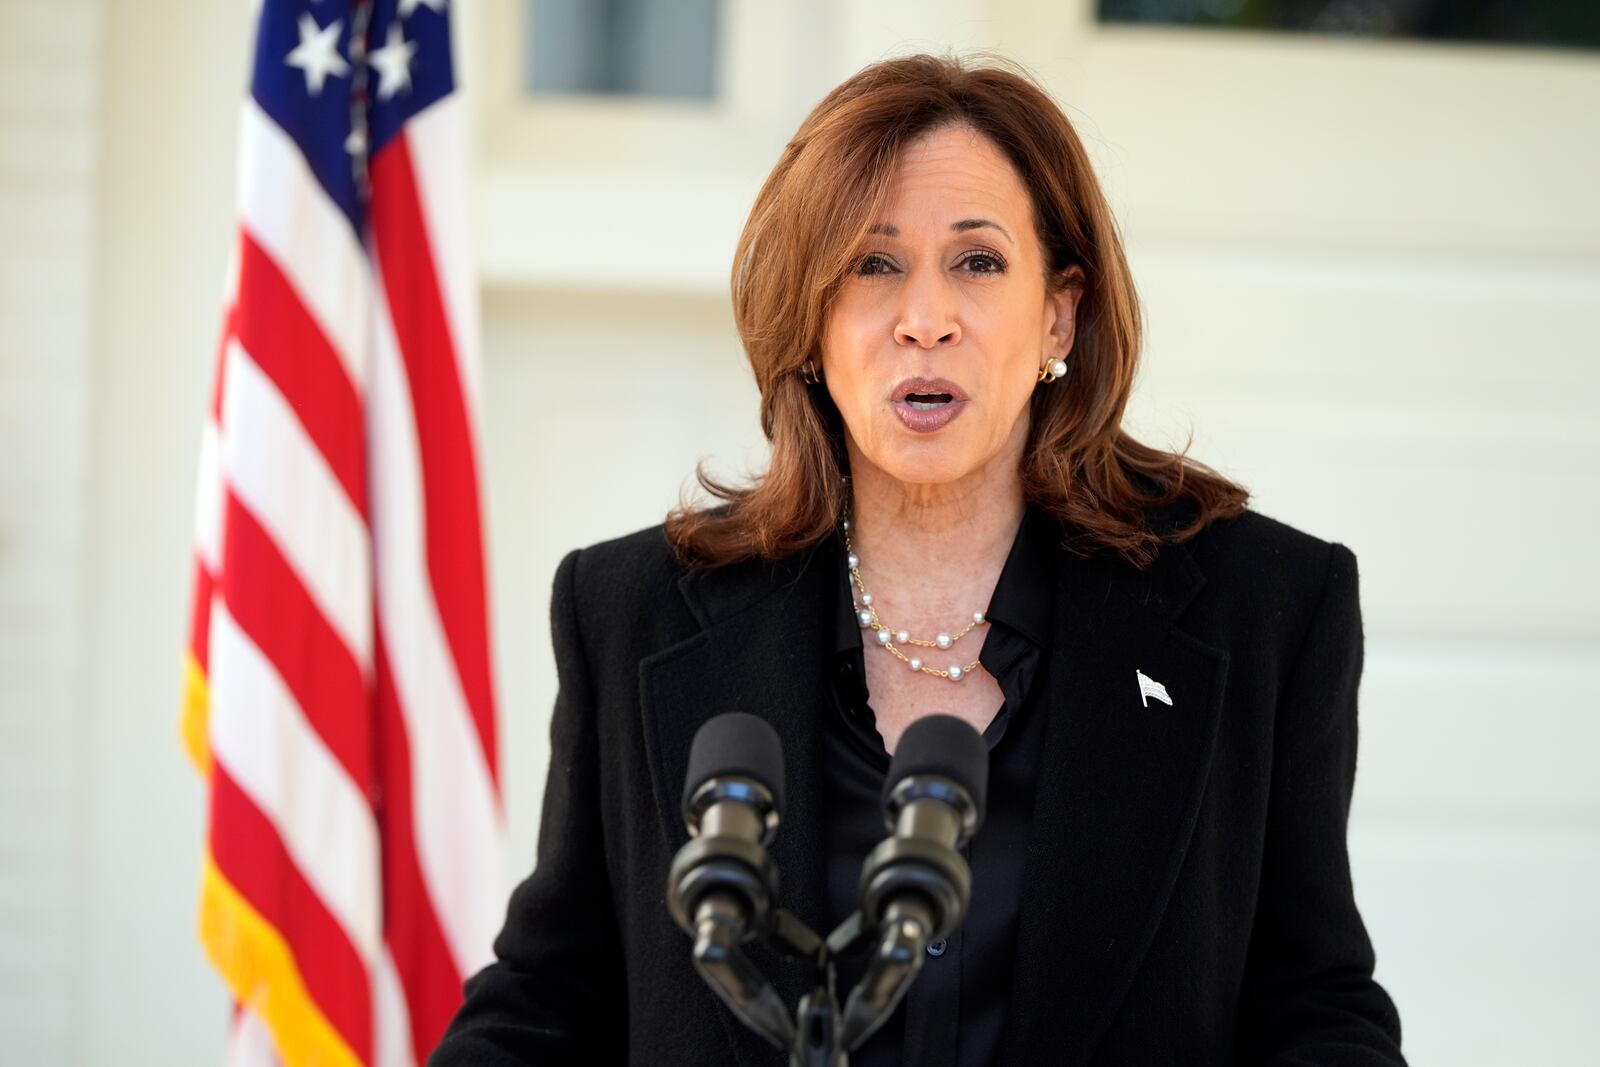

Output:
xmin=72 ymin=0 xmax=250 ymax=1064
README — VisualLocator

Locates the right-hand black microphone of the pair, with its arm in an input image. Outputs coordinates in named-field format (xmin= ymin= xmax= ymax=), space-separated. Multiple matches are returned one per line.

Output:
xmin=830 ymin=715 xmax=989 ymax=1049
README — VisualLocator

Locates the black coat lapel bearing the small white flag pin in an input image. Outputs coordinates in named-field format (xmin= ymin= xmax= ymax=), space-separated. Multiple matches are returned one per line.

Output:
xmin=1002 ymin=531 xmax=1227 ymax=1064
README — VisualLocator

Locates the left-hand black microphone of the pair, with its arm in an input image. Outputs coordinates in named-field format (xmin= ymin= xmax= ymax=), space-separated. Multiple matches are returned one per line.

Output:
xmin=667 ymin=712 xmax=795 ymax=1048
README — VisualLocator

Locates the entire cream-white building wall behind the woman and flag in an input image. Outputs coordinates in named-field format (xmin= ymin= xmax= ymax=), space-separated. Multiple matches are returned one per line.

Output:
xmin=0 ymin=0 xmax=1600 ymax=1065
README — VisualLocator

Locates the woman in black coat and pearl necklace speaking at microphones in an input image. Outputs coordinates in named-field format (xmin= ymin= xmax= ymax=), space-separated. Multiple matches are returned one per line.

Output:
xmin=432 ymin=56 xmax=1403 ymax=1065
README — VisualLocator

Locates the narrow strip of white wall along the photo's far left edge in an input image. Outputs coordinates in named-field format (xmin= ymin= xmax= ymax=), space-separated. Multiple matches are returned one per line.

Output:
xmin=0 ymin=0 xmax=102 ymax=1062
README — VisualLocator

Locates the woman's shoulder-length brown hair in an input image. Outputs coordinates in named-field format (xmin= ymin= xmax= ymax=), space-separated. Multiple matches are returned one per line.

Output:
xmin=666 ymin=54 xmax=1248 ymax=568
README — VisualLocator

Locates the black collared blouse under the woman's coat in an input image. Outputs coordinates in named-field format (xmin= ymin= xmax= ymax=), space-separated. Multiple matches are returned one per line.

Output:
xmin=822 ymin=506 xmax=1061 ymax=1067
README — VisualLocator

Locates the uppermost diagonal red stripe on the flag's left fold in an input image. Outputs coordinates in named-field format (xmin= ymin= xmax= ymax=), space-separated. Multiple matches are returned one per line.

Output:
xmin=234 ymin=234 xmax=366 ymax=518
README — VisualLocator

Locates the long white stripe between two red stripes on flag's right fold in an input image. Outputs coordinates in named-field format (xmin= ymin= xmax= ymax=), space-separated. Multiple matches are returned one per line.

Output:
xmin=366 ymin=253 xmax=507 ymax=976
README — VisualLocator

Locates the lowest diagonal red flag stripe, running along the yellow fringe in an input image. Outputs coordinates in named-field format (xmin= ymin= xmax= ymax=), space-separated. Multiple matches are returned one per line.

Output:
xmin=211 ymin=761 xmax=373 ymax=1064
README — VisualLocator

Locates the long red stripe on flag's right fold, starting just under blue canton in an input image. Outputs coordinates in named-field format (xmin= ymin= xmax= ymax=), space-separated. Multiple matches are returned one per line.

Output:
xmin=371 ymin=133 xmax=499 ymax=781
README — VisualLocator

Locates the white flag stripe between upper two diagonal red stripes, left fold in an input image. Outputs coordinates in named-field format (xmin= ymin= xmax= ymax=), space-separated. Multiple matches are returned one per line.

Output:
xmin=221 ymin=341 xmax=373 ymax=672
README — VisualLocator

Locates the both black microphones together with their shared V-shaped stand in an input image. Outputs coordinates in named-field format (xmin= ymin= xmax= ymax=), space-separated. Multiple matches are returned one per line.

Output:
xmin=667 ymin=712 xmax=989 ymax=1067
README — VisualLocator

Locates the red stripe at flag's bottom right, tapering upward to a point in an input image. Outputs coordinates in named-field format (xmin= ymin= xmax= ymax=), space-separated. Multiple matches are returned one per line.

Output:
xmin=374 ymin=637 xmax=464 ymax=1064
